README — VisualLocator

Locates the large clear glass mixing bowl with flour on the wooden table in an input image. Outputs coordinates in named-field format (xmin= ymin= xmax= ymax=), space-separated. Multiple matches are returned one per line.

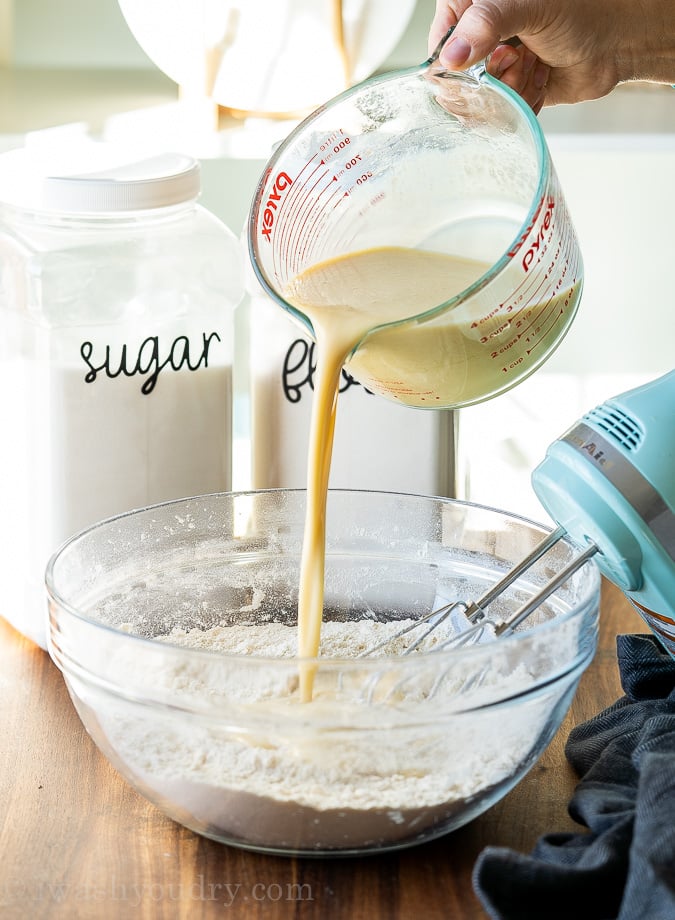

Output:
xmin=47 ymin=490 xmax=600 ymax=855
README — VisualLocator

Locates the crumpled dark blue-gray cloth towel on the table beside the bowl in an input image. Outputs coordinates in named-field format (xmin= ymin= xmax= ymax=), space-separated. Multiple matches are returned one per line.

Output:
xmin=473 ymin=635 xmax=675 ymax=920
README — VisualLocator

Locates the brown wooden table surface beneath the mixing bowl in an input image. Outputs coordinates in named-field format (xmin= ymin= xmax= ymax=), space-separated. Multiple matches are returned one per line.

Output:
xmin=0 ymin=584 xmax=646 ymax=920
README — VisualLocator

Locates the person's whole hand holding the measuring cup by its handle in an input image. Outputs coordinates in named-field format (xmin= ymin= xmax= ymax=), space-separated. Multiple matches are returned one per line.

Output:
xmin=429 ymin=0 xmax=675 ymax=112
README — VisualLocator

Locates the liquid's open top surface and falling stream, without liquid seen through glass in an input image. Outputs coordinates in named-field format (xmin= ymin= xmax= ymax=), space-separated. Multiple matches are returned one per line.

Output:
xmin=284 ymin=248 xmax=487 ymax=701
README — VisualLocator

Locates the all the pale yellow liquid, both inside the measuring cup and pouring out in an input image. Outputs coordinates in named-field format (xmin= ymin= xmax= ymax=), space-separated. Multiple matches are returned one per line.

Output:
xmin=283 ymin=247 xmax=579 ymax=701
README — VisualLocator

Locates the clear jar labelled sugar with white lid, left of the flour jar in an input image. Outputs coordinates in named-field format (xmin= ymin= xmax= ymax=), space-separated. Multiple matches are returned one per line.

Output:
xmin=0 ymin=145 xmax=243 ymax=647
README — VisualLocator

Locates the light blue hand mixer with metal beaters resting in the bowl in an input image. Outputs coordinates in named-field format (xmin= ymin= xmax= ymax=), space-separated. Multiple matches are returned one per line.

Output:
xmin=364 ymin=370 xmax=675 ymax=658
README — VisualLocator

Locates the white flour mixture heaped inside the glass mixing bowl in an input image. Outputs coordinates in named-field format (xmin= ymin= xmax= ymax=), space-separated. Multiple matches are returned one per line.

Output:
xmin=83 ymin=620 xmax=569 ymax=852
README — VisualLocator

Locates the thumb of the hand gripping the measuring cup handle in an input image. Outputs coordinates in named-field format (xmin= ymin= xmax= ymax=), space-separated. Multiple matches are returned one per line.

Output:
xmin=439 ymin=0 xmax=526 ymax=70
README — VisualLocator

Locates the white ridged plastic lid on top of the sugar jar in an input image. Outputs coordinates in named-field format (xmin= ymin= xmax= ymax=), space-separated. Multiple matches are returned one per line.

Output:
xmin=0 ymin=143 xmax=201 ymax=214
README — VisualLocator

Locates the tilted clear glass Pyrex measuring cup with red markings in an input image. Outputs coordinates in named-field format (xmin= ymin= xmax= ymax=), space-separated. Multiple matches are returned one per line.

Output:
xmin=249 ymin=35 xmax=583 ymax=408
